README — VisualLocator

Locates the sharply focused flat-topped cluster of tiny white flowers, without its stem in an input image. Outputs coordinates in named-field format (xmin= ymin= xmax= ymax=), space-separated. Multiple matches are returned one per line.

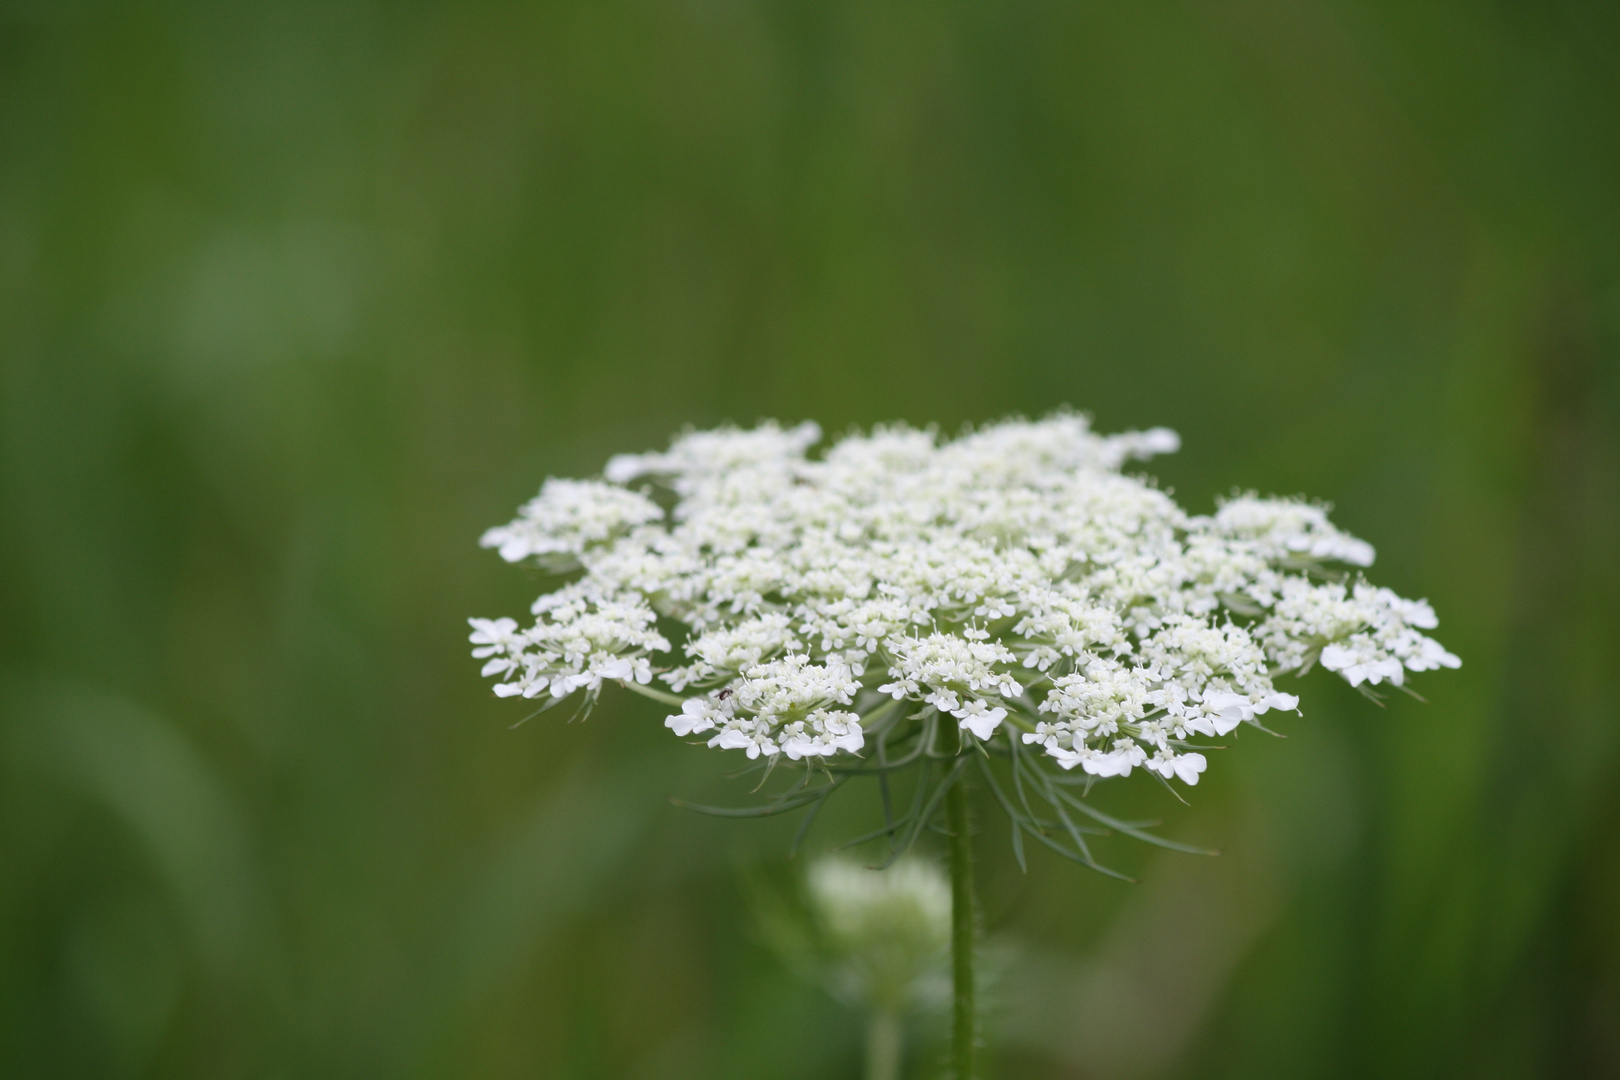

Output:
xmin=471 ymin=413 xmax=1458 ymax=784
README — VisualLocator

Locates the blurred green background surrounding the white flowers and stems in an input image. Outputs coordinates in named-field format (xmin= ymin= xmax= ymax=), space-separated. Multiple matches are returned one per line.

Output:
xmin=0 ymin=0 xmax=1620 ymax=1080
